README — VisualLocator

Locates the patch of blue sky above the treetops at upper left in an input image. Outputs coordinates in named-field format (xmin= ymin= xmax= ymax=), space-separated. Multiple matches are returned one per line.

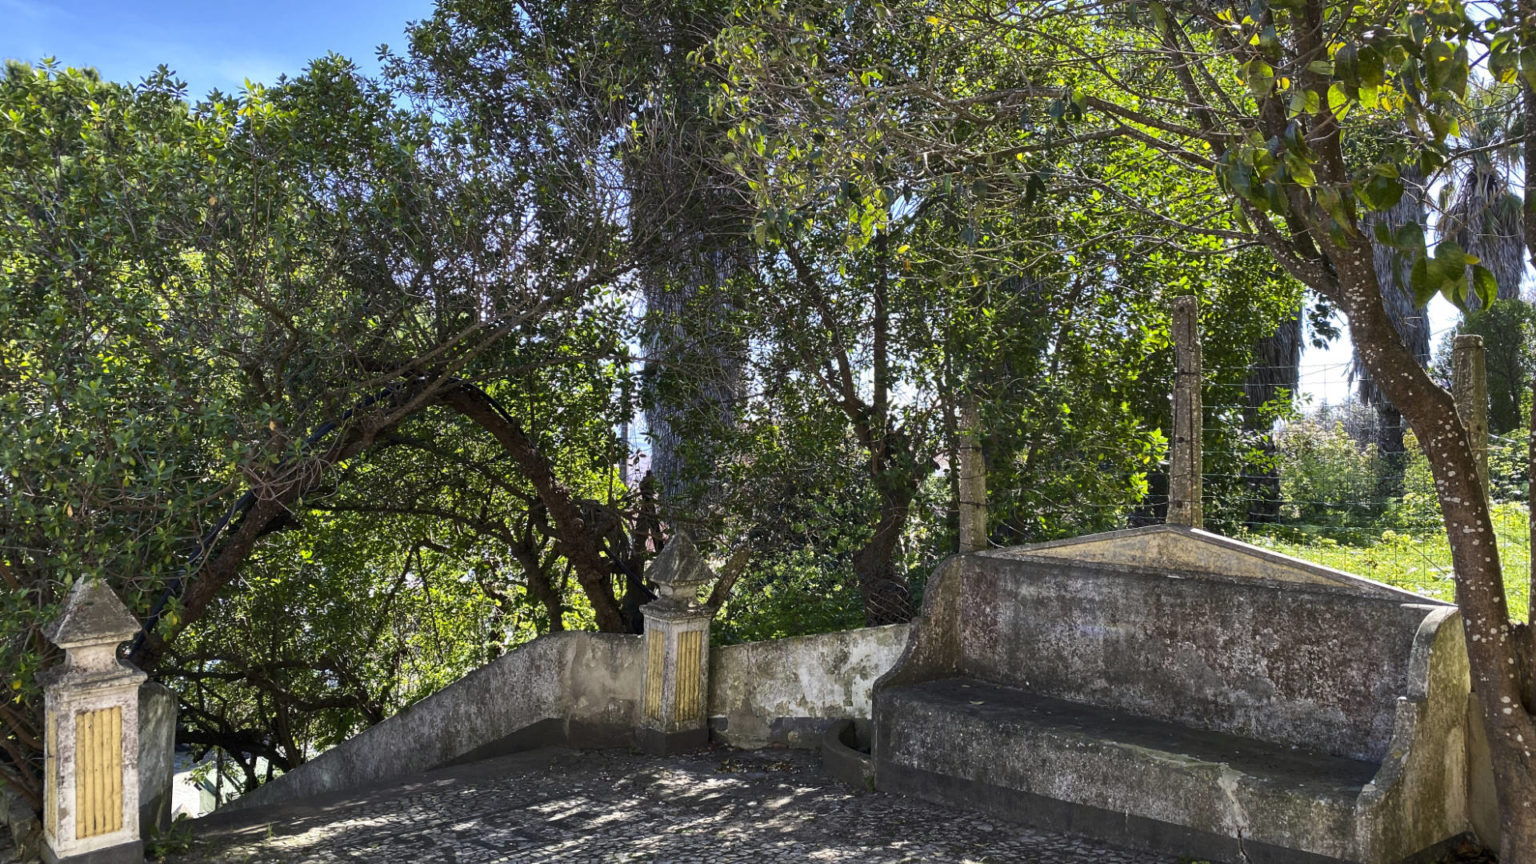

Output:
xmin=0 ymin=0 xmax=432 ymax=98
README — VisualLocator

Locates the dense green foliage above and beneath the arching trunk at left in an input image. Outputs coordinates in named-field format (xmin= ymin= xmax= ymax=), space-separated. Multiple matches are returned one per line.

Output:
xmin=0 ymin=50 xmax=638 ymax=795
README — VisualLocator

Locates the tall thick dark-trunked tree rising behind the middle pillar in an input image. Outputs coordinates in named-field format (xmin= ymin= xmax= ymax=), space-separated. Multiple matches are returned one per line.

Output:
xmin=410 ymin=0 xmax=753 ymax=521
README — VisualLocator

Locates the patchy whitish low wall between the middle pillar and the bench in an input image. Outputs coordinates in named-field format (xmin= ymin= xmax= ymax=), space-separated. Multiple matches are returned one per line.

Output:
xmin=710 ymin=624 xmax=908 ymax=747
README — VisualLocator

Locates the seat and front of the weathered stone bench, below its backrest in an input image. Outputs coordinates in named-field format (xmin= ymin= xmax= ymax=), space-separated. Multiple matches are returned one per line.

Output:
xmin=882 ymin=678 xmax=1379 ymax=861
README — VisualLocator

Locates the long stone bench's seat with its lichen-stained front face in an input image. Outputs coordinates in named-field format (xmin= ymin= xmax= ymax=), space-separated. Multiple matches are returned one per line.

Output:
xmin=876 ymin=680 xmax=1376 ymax=864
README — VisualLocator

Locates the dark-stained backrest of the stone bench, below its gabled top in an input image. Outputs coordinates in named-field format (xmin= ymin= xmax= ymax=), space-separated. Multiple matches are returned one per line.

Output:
xmin=957 ymin=558 xmax=1432 ymax=761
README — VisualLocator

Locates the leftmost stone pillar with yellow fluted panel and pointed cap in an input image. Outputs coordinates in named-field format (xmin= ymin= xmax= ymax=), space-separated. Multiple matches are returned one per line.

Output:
xmin=43 ymin=580 xmax=146 ymax=864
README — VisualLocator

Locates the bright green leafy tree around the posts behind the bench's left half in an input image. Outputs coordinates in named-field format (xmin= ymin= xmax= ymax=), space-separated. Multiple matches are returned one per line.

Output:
xmin=716 ymin=3 xmax=1298 ymax=618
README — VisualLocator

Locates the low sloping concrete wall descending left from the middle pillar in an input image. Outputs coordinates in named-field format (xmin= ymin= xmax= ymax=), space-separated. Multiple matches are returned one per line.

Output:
xmin=224 ymin=632 xmax=645 ymax=809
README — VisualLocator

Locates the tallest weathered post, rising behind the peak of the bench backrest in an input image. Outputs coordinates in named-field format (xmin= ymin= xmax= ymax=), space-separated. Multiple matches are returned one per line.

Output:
xmin=1167 ymin=295 xmax=1204 ymax=527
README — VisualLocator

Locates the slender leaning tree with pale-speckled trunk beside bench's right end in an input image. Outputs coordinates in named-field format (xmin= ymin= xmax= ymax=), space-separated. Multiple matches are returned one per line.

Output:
xmin=1032 ymin=0 xmax=1536 ymax=862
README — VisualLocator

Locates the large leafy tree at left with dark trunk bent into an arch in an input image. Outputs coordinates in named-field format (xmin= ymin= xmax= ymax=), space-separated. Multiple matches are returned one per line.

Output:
xmin=0 ymin=48 xmax=662 ymax=806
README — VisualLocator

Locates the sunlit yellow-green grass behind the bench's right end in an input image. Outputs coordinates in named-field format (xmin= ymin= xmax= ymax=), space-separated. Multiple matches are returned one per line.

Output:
xmin=1241 ymin=503 xmax=1530 ymax=621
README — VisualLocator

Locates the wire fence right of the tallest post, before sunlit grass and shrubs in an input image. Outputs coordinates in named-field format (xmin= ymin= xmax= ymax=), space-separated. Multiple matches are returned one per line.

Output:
xmin=1173 ymin=358 xmax=1531 ymax=618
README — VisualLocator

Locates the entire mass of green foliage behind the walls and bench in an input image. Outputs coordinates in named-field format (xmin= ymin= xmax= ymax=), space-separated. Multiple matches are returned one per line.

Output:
xmin=9 ymin=0 xmax=1531 ymax=836
